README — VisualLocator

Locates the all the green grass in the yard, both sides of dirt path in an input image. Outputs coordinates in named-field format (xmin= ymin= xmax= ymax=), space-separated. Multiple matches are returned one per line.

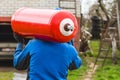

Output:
xmin=0 ymin=40 xmax=120 ymax=80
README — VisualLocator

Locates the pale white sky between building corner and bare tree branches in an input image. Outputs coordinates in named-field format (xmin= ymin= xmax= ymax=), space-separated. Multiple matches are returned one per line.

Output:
xmin=80 ymin=0 xmax=97 ymax=14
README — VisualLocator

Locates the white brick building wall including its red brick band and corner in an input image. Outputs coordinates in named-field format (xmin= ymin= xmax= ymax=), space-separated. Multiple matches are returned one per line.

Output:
xmin=0 ymin=0 xmax=80 ymax=51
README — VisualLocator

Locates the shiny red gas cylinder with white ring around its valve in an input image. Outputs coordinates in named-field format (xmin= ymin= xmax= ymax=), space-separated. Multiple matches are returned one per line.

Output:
xmin=11 ymin=8 xmax=78 ymax=42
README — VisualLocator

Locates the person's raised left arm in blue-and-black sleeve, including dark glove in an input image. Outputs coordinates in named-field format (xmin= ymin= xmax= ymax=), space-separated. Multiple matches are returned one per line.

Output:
xmin=13 ymin=33 xmax=30 ymax=70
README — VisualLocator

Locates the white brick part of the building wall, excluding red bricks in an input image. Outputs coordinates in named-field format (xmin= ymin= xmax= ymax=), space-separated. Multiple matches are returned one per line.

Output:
xmin=0 ymin=0 xmax=80 ymax=17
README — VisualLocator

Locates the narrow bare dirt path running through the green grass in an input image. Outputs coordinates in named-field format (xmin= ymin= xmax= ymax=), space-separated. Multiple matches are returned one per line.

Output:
xmin=83 ymin=63 xmax=97 ymax=80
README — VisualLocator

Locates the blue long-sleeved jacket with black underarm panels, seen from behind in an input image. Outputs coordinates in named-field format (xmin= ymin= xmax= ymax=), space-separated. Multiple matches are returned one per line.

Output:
xmin=14 ymin=39 xmax=82 ymax=80
